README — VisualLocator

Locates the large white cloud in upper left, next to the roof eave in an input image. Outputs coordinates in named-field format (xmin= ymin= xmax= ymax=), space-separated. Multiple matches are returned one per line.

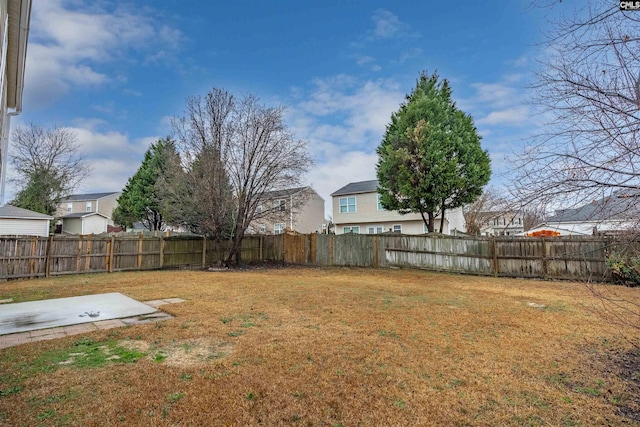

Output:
xmin=25 ymin=0 xmax=182 ymax=108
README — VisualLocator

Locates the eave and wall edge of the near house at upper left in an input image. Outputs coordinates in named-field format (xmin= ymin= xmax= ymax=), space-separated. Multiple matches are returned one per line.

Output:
xmin=0 ymin=0 xmax=31 ymax=204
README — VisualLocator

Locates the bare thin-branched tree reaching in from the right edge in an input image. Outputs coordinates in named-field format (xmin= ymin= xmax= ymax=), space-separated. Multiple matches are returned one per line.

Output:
xmin=514 ymin=1 xmax=640 ymax=212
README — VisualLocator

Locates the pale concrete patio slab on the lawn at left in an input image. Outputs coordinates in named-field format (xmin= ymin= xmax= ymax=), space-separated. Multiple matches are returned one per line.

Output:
xmin=0 ymin=292 xmax=157 ymax=335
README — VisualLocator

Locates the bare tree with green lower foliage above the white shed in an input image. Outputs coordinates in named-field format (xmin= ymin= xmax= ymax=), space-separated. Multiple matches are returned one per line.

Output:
xmin=10 ymin=124 xmax=89 ymax=215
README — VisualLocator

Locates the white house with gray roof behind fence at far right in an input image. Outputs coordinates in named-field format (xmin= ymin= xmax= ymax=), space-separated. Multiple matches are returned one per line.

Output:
xmin=524 ymin=191 xmax=640 ymax=236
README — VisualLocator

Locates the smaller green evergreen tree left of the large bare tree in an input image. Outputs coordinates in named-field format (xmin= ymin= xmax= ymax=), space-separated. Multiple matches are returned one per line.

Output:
xmin=113 ymin=138 xmax=178 ymax=231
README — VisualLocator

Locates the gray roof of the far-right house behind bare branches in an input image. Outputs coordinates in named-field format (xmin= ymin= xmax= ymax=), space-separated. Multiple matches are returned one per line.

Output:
xmin=546 ymin=191 xmax=640 ymax=222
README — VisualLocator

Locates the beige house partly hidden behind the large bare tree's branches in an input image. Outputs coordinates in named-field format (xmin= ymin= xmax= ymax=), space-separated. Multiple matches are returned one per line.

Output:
xmin=247 ymin=187 xmax=325 ymax=234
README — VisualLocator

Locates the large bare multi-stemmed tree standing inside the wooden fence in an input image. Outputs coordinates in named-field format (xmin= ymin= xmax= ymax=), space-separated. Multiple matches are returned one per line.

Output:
xmin=173 ymin=88 xmax=311 ymax=265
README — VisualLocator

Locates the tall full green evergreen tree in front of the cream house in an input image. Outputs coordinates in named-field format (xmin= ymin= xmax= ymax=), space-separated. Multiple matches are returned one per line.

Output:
xmin=377 ymin=72 xmax=491 ymax=232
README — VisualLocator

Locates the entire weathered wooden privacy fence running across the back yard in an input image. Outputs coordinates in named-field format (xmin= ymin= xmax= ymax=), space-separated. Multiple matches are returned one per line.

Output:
xmin=0 ymin=234 xmax=625 ymax=280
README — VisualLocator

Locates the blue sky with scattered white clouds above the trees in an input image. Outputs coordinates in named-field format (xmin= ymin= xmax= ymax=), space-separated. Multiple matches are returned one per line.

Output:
xmin=7 ymin=0 xmax=546 ymax=217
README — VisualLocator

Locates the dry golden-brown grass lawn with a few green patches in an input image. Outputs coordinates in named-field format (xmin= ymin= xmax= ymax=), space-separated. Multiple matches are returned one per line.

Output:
xmin=0 ymin=268 xmax=640 ymax=427
